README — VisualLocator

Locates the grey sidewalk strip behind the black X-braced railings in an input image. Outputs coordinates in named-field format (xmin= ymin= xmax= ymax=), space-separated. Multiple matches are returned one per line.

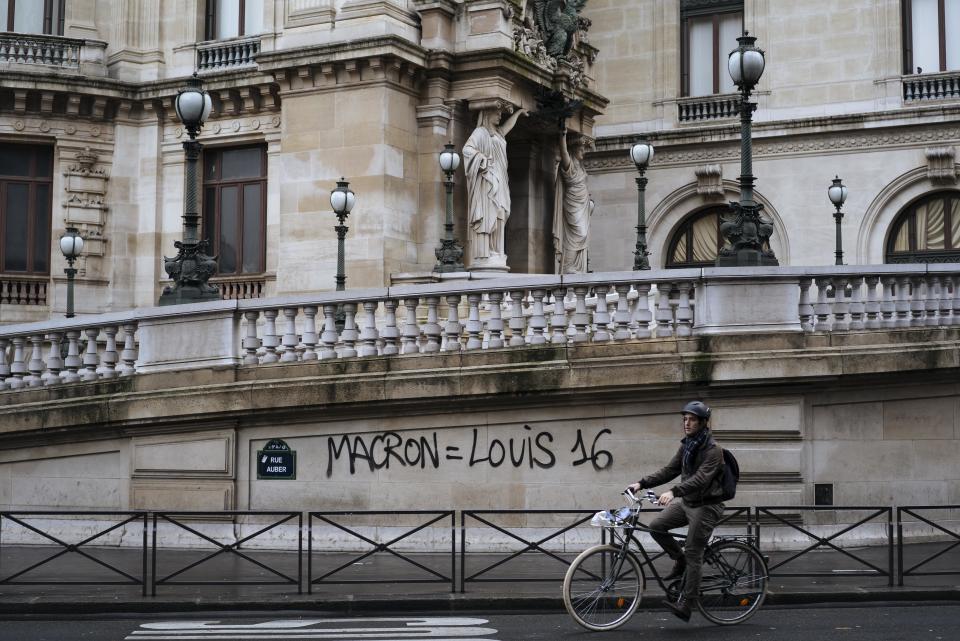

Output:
xmin=0 ymin=543 xmax=960 ymax=615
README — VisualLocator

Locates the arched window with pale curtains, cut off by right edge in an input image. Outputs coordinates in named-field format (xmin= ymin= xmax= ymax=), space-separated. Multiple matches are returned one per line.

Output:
xmin=886 ymin=191 xmax=960 ymax=263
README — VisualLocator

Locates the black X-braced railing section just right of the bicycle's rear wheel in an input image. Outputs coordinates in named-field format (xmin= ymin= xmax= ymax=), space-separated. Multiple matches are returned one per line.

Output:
xmin=754 ymin=506 xmax=902 ymax=586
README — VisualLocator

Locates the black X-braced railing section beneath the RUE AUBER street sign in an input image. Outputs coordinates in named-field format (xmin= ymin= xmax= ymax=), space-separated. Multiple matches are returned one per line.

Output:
xmin=150 ymin=510 xmax=303 ymax=596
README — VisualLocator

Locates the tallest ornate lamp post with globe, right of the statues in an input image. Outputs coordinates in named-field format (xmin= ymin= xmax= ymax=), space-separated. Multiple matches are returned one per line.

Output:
xmin=717 ymin=32 xmax=779 ymax=267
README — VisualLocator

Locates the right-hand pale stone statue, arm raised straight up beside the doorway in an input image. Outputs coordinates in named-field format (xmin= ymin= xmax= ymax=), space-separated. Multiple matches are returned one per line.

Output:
xmin=553 ymin=128 xmax=593 ymax=274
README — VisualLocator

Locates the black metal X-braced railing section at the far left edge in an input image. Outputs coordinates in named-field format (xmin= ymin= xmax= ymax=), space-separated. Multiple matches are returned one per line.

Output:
xmin=0 ymin=511 xmax=147 ymax=596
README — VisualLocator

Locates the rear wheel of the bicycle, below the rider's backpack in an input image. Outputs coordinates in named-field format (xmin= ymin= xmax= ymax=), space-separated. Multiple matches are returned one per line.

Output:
xmin=698 ymin=541 xmax=767 ymax=625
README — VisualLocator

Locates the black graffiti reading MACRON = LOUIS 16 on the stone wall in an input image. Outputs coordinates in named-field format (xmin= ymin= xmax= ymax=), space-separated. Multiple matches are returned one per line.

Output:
xmin=327 ymin=425 xmax=613 ymax=478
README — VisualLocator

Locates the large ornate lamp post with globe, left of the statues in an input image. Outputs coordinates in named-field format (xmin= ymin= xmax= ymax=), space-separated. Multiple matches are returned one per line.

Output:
xmin=160 ymin=73 xmax=220 ymax=305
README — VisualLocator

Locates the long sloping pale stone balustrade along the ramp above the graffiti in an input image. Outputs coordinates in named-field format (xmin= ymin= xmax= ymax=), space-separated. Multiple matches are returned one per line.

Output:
xmin=0 ymin=265 xmax=960 ymax=391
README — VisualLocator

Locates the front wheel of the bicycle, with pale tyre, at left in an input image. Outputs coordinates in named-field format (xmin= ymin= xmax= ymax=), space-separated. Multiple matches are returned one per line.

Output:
xmin=563 ymin=545 xmax=645 ymax=630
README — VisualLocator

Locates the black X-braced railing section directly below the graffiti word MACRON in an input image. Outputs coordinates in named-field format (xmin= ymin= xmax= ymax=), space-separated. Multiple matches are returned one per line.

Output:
xmin=307 ymin=510 xmax=457 ymax=594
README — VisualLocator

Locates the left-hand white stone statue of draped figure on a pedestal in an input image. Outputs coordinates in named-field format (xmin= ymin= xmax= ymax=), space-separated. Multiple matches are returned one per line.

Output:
xmin=463 ymin=107 xmax=527 ymax=271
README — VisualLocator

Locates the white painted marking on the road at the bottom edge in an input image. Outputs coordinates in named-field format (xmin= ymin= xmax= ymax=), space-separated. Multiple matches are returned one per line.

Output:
xmin=126 ymin=617 xmax=497 ymax=641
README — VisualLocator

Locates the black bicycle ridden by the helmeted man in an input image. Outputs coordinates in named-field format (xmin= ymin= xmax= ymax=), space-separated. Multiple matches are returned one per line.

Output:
xmin=563 ymin=490 xmax=768 ymax=631
